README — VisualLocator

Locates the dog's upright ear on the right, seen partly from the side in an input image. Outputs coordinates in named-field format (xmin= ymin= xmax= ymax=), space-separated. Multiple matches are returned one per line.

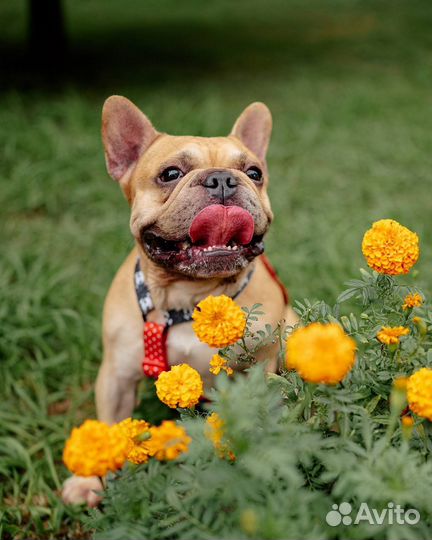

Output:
xmin=231 ymin=101 xmax=272 ymax=161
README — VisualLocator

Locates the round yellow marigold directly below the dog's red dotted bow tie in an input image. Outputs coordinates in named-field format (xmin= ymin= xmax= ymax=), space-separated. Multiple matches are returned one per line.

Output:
xmin=156 ymin=364 xmax=203 ymax=409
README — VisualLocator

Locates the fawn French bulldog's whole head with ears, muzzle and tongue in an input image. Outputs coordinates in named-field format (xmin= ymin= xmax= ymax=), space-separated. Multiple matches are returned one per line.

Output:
xmin=102 ymin=96 xmax=272 ymax=278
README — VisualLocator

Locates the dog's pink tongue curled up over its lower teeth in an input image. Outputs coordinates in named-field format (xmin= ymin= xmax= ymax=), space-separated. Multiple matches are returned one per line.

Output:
xmin=189 ymin=204 xmax=254 ymax=247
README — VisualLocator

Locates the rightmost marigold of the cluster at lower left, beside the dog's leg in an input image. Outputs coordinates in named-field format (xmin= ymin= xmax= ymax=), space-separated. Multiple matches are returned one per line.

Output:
xmin=145 ymin=420 xmax=192 ymax=461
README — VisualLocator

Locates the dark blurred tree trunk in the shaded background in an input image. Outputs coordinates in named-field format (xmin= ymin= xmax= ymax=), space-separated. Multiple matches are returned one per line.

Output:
xmin=28 ymin=0 xmax=66 ymax=67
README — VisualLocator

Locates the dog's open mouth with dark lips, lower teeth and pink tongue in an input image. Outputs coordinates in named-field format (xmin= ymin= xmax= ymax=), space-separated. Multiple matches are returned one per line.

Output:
xmin=141 ymin=205 xmax=264 ymax=277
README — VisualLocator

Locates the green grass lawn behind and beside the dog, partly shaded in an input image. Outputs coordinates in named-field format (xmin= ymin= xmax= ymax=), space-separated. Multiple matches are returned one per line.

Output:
xmin=0 ymin=0 xmax=432 ymax=538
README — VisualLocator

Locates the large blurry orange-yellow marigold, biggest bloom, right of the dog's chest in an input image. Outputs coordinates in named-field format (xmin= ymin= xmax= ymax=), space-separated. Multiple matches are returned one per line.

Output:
xmin=286 ymin=323 xmax=356 ymax=384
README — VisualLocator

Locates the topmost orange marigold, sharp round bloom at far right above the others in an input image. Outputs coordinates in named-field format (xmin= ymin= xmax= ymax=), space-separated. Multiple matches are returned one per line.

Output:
xmin=362 ymin=219 xmax=420 ymax=276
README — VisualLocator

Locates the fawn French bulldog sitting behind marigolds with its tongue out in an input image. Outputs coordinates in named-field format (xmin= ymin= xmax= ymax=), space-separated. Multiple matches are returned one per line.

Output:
xmin=63 ymin=96 xmax=297 ymax=505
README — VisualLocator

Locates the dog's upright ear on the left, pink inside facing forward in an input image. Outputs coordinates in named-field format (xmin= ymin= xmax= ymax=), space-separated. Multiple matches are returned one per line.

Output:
xmin=102 ymin=96 xmax=158 ymax=181
